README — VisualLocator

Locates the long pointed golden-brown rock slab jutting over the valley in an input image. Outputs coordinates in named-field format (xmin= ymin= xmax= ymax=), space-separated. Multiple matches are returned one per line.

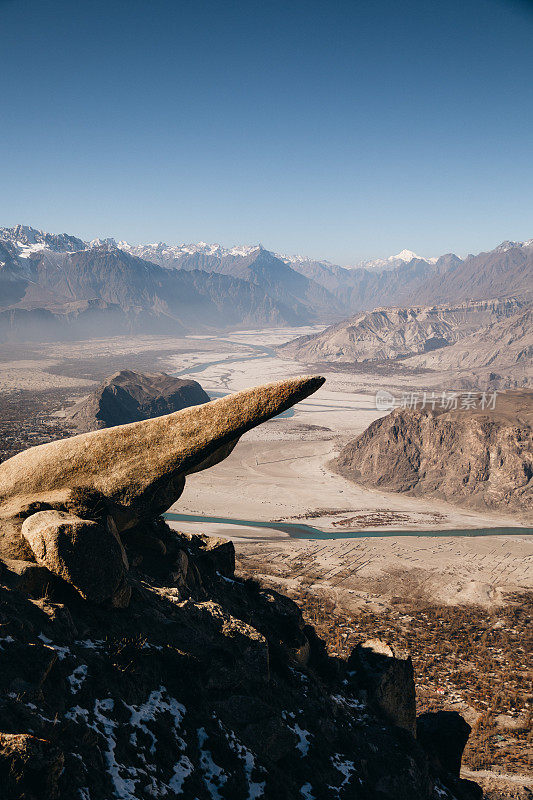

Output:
xmin=0 ymin=377 xmax=324 ymax=529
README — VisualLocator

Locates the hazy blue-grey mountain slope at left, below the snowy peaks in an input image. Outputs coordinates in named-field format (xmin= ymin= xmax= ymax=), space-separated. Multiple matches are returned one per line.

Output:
xmin=0 ymin=240 xmax=309 ymax=338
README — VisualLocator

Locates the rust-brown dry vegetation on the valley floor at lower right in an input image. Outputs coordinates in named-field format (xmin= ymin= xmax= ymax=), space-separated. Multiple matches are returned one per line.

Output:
xmin=241 ymin=561 xmax=533 ymax=775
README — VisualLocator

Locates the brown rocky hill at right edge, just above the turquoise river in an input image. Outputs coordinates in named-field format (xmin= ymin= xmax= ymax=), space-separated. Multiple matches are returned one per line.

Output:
xmin=334 ymin=390 xmax=533 ymax=516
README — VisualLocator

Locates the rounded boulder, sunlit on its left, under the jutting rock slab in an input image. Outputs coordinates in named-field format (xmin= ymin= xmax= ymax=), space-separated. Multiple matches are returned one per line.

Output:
xmin=22 ymin=511 xmax=125 ymax=603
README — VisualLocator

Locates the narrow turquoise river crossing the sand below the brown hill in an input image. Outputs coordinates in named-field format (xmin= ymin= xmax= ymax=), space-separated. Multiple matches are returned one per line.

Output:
xmin=163 ymin=511 xmax=533 ymax=539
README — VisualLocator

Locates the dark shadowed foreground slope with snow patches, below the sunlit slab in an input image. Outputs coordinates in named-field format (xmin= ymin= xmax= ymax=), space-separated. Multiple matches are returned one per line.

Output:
xmin=0 ymin=520 xmax=478 ymax=800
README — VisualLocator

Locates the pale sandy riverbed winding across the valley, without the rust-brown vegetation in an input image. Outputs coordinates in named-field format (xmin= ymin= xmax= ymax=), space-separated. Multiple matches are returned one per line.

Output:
xmin=0 ymin=329 xmax=533 ymax=603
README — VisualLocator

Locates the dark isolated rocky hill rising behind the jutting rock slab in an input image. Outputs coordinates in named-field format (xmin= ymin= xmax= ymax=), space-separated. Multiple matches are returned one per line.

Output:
xmin=66 ymin=370 xmax=210 ymax=431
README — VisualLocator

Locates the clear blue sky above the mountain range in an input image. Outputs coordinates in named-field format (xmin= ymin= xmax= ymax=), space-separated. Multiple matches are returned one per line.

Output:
xmin=0 ymin=0 xmax=533 ymax=263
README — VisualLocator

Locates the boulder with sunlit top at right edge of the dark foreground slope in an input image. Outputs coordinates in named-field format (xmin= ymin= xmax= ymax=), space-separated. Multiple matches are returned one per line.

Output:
xmin=348 ymin=639 xmax=416 ymax=736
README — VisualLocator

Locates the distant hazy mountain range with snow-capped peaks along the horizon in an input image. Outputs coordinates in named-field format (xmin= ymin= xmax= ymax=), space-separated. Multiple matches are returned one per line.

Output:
xmin=0 ymin=225 xmax=533 ymax=341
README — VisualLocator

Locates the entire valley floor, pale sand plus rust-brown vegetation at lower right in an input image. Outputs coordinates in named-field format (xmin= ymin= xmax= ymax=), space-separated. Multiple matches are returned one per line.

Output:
xmin=0 ymin=329 xmax=533 ymax=798
